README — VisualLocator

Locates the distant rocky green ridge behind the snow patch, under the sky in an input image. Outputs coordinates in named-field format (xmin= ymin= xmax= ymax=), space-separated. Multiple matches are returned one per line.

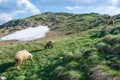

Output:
xmin=0 ymin=12 xmax=108 ymax=34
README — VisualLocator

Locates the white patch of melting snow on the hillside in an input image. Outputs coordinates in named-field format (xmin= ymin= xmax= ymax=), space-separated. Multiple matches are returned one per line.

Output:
xmin=1 ymin=26 xmax=49 ymax=41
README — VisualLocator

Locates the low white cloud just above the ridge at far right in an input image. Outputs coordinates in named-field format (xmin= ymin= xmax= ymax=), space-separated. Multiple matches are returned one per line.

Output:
xmin=75 ymin=6 xmax=120 ymax=15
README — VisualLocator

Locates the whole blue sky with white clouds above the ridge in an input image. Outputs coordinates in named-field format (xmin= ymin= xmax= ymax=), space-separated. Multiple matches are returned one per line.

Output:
xmin=0 ymin=0 xmax=120 ymax=24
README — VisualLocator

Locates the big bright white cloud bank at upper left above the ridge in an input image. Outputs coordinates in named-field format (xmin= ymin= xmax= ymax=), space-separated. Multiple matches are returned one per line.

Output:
xmin=0 ymin=0 xmax=40 ymax=22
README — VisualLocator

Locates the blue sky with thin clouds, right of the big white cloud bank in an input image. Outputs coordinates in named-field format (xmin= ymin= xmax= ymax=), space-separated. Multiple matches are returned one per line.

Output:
xmin=36 ymin=0 xmax=120 ymax=15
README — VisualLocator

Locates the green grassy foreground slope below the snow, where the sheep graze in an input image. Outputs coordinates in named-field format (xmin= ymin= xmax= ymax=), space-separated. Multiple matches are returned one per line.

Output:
xmin=0 ymin=27 xmax=120 ymax=80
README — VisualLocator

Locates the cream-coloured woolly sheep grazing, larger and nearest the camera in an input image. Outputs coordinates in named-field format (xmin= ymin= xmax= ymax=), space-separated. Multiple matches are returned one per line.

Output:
xmin=14 ymin=50 xmax=32 ymax=69
